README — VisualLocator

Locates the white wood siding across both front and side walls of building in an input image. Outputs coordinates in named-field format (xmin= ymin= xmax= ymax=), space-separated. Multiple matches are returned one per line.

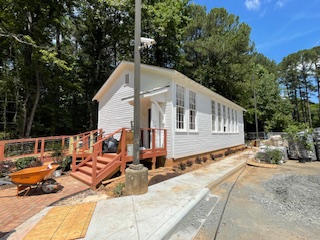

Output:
xmin=98 ymin=63 xmax=244 ymax=158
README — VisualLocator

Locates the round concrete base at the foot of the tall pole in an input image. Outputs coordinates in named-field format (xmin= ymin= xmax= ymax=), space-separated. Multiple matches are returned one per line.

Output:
xmin=125 ymin=164 xmax=148 ymax=195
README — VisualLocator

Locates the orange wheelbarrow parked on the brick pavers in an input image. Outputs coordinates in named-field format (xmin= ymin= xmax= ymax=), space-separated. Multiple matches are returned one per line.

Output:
xmin=9 ymin=165 xmax=60 ymax=196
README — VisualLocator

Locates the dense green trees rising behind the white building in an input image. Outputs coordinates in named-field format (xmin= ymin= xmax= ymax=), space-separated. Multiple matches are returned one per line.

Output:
xmin=0 ymin=0 xmax=320 ymax=138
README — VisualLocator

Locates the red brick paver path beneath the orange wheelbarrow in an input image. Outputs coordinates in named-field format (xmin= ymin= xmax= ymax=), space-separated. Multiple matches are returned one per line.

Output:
xmin=0 ymin=176 xmax=89 ymax=238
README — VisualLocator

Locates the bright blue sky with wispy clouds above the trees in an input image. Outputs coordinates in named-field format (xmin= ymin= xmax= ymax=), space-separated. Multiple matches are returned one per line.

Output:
xmin=190 ymin=0 xmax=320 ymax=63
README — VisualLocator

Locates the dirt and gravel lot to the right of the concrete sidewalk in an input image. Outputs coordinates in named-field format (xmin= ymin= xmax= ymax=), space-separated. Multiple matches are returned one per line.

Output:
xmin=196 ymin=160 xmax=320 ymax=240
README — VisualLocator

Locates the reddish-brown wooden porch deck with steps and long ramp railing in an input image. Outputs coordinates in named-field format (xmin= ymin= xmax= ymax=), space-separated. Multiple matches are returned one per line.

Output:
xmin=0 ymin=128 xmax=167 ymax=188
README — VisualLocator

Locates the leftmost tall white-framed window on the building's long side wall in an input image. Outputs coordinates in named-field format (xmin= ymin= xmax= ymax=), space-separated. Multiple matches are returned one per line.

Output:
xmin=175 ymin=84 xmax=186 ymax=131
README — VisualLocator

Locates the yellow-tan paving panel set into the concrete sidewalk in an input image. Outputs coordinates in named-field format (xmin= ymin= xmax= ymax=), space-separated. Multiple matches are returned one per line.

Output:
xmin=24 ymin=203 xmax=96 ymax=240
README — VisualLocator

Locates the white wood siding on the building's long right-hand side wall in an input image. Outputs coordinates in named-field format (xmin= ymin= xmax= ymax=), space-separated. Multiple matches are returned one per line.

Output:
xmin=171 ymin=73 xmax=244 ymax=158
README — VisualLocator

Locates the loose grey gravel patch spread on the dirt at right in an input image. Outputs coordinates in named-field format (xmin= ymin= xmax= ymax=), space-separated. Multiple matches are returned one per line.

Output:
xmin=251 ymin=174 xmax=320 ymax=226
